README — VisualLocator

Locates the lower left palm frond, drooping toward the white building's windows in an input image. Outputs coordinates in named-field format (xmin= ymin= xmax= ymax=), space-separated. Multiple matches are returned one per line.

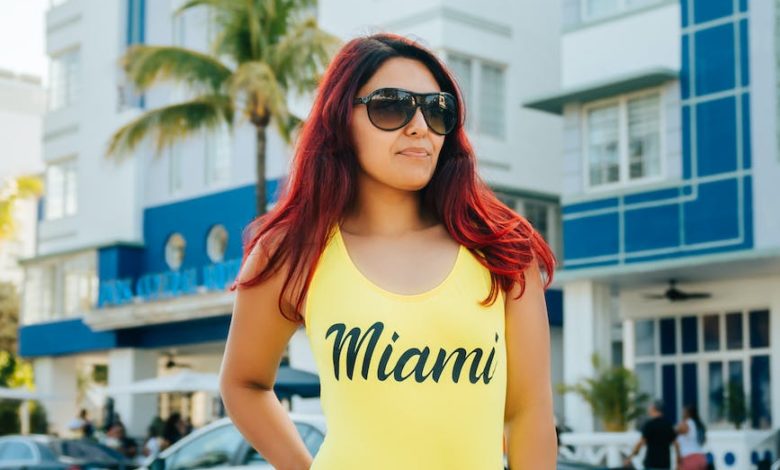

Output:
xmin=106 ymin=95 xmax=233 ymax=156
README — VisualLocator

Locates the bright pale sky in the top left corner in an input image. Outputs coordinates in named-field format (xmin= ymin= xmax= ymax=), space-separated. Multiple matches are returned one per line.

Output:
xmin=0 ymin=0 xmax=49 ymax=83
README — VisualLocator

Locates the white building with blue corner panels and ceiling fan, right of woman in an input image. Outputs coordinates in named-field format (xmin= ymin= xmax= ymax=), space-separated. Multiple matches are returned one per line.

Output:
xmin=526 ymin=0 xmax=780 ymax=469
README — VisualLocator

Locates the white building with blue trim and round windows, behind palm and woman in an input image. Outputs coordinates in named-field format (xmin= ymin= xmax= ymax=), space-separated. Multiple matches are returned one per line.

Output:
xmin=20 ymin=0 xmax=562 ymax=435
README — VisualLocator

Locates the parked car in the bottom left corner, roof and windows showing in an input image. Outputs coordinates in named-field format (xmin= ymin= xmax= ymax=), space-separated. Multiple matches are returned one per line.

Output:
xmin=0 ymin=435 xmax=136 ymax=470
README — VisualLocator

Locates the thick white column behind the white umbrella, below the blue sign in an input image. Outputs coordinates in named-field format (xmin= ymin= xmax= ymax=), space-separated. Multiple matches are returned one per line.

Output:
xmin=108 ymin=348 xmax=158 ymax=437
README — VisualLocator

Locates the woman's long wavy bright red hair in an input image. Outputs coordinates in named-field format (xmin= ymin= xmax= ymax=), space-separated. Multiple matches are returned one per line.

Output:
xmin=231 ymin=33 xmax=555 ymax=322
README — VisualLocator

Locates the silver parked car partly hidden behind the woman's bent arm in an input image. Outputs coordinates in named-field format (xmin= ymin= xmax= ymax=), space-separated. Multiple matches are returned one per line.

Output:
xmin=142 ymin=413 xmax=325 ymax=470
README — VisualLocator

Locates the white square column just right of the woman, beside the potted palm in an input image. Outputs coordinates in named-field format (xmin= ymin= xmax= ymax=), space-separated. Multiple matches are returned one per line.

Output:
xmin=563 ymin=280 xmax=611 ymax=432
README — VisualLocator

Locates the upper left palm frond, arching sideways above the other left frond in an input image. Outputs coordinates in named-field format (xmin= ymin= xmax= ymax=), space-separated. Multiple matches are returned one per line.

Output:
xmin=123 ymin=45 xmax=232 ymax=93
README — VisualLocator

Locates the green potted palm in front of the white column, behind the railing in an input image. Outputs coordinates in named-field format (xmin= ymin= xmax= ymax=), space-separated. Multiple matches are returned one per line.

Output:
xmin=558 ymin=354 xmax=650 ymax=432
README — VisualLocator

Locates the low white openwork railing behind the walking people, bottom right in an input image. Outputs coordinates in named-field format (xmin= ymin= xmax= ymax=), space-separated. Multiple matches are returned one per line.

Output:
xmin=560 ymin=431 xmax=777 ymax=470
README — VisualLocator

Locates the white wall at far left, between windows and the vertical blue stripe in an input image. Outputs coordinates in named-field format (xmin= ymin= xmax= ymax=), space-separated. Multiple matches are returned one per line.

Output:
xmin=38 ymin=0 xmax=141 ymax=254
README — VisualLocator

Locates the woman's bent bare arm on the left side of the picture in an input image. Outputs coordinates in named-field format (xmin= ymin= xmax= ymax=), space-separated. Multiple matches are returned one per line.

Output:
xmin=220 ymin=247 xmax=312 ymax=470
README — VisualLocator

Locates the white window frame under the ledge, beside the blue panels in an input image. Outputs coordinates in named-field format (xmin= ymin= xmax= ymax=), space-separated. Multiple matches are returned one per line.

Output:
xmin=579 ymin=87 xmax=667 ymax=193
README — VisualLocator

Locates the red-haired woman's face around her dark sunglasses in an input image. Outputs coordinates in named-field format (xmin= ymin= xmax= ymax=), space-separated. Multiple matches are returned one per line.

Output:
xmin=350 ymin=57 xmax=444 ymax=191
